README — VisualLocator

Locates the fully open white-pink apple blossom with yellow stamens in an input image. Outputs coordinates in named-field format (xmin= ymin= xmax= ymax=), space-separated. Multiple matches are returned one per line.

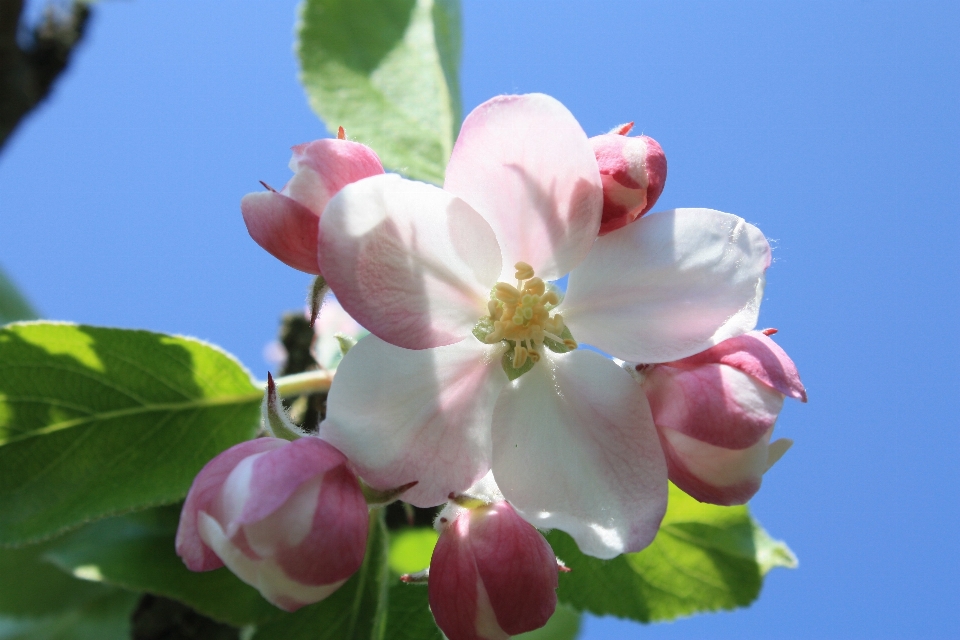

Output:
xmin=319 ymin=94 xmax=770 ymax=558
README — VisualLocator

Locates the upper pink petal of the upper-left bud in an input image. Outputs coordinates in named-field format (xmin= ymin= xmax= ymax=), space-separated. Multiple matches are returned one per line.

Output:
xmin=282 ymin=138 xmax=383 ymax=218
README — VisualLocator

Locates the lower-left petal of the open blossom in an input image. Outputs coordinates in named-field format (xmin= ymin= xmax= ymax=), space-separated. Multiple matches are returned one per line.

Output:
xmin=320 ymin=336 xmax=507 ymax=507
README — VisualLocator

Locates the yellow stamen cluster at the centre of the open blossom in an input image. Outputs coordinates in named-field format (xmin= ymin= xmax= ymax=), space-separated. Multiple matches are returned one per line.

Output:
xmin=478 ymin=262 xmax=577 ymax=369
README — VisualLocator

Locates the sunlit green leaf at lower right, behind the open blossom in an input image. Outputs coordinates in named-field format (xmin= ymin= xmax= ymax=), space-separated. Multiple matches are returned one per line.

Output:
xmin=547 ymin=484 xmax=797 ymax=622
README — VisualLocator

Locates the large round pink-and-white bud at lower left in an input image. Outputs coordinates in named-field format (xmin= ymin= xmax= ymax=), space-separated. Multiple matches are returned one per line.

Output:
xmin=177 ymin=437 xmax=369 ymax=611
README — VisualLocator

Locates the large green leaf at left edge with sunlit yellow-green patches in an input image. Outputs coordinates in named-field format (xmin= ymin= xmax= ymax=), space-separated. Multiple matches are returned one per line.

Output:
xmin=0 ymin=322 xmax=262 ymax=545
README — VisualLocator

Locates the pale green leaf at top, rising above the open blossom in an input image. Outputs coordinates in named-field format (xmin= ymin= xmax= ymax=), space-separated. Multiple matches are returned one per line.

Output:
xmin=298 ymin=0 xmax=461 ymax=184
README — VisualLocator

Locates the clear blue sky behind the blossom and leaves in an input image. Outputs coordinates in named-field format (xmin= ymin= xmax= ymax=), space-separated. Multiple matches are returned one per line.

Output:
xmin=0 ymin=0 xmax=960 ymax=640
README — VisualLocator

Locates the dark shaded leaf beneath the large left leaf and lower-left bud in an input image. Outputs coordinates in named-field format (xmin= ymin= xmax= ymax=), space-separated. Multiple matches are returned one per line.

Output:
xmin=45 ymin=505 xmax=282 ymax=627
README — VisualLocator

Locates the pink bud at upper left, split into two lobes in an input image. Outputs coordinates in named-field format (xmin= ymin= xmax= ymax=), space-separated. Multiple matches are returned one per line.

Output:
xmin=240 ymin=139 xmax=383 ymax=274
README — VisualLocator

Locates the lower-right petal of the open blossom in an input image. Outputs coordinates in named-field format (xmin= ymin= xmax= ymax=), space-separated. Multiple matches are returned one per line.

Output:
xmin=493 ymin=350 xmax=667 ymax=558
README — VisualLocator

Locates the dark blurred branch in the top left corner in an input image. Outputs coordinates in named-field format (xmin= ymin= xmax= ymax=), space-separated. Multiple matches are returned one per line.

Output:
xmin=0 ymin=0 xmax=90 ymax=149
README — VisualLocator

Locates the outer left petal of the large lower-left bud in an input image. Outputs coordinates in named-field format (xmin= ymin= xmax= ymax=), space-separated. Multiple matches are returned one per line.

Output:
xmin=176 ymin=438 xmax=286 ymax=571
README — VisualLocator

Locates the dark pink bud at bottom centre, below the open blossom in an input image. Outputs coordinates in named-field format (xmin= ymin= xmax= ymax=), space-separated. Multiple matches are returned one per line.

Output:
xmin=429 ymin=502 xmax=557 ymax=640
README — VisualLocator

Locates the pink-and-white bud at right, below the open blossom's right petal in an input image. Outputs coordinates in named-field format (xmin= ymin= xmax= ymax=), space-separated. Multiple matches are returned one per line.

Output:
xmin=643 ymin=331 xmax=807 ymax=505
